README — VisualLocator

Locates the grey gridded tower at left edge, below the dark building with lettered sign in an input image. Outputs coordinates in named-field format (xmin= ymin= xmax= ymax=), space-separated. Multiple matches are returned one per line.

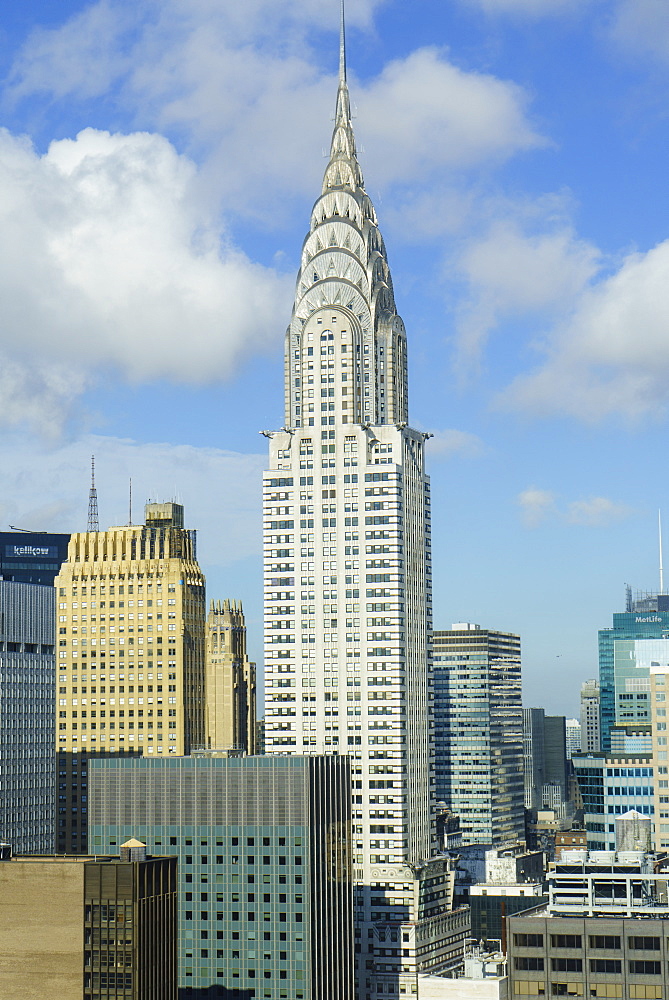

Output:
xmin=0 ymin=580 xmax=56 ymax=854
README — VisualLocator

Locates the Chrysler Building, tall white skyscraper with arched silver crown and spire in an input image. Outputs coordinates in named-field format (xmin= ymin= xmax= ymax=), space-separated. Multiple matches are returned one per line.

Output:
xmin=264 ymin=5 xmax=464 ymax=1000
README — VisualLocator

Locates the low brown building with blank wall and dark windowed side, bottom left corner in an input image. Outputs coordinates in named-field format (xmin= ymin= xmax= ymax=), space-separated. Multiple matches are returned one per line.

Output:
xmin=0 ymin=844 xmax=176 ymax=1000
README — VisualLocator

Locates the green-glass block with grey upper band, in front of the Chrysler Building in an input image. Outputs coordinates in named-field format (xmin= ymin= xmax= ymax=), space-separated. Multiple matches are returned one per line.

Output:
xmin=89 ymin=756 xmax=353 ymax=1000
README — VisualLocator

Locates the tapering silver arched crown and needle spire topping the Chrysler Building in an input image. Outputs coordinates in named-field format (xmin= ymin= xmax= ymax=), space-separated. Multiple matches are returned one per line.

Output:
xmin=285 ymin=0 xmax=408 ymax=428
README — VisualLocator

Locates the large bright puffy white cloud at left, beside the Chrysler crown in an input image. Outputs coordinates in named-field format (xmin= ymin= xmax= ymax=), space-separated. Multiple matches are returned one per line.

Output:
xmin=0 ymin=129 xmax=292 ymax=434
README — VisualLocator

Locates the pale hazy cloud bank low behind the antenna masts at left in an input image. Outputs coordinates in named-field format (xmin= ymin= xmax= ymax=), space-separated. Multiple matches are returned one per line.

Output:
xmin=0 ymin=435 xmax=267 ymax=567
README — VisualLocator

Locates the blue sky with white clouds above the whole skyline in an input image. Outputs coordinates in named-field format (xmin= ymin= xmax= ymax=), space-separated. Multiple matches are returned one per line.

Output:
xmin=0 ymin=0 xmax=669 ymax=714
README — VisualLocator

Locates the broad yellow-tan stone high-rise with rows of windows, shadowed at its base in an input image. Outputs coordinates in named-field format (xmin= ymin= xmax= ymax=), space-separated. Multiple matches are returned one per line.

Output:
xmin=55 ymin=503 xmax=206 ymax=853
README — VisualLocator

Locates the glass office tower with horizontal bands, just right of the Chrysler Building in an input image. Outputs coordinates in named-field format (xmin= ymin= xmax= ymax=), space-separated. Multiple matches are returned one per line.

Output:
xmin=433 ymin=623 xmax=525 ymax=847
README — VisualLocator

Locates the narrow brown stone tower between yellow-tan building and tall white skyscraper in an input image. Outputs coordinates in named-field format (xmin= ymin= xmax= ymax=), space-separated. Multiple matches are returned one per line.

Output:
xmin=205 ymin=601 xmax=256 ymax=754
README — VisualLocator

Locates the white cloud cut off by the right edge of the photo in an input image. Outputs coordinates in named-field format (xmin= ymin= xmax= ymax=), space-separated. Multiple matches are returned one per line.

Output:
xmin=502 ymin=241 xmax=669 ymax=420
